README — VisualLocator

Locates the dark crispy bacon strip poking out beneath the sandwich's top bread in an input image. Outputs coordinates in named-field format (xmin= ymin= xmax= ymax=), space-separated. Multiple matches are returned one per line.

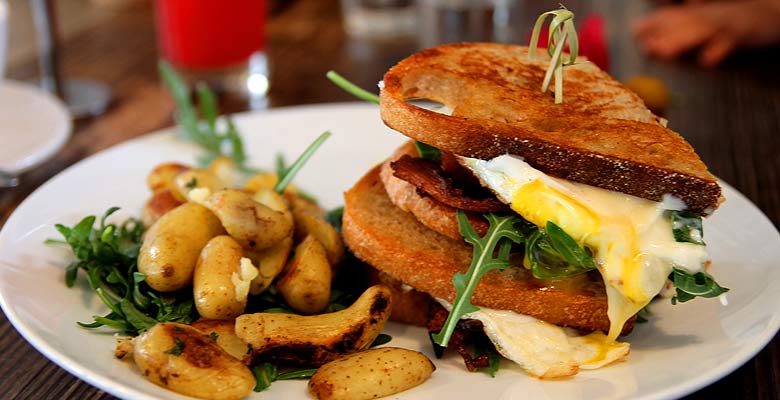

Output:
xmin=390 ymin=155 xmax=509 ymax=213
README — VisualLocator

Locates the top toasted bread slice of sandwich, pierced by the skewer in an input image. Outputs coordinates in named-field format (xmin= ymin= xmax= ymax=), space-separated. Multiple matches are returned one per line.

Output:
xmin=380 ymin=43 xmax=722 ymax=214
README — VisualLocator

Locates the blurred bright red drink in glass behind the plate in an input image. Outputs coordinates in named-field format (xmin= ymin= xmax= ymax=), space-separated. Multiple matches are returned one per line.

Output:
xmin=155 ymin=0 xmax=267 ymax=70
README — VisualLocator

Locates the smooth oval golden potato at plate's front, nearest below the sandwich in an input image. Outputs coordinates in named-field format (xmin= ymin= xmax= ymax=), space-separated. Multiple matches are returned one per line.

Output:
xmin=309 ymin=347 xmax=436 ymax=400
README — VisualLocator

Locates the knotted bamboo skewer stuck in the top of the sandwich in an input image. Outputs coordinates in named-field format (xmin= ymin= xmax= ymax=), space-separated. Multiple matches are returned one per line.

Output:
xmin=528 ymin=6 xmax=579 ymax=104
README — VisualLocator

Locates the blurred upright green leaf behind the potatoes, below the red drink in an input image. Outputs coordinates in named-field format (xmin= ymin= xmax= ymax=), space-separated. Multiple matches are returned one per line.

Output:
xmin=158 ymin=61 xmax=252 ymax=171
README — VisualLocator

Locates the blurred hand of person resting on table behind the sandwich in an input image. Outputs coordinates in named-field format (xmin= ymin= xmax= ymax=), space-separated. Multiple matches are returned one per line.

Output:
xmin=633 ymin=0 xmax=780 ymax=66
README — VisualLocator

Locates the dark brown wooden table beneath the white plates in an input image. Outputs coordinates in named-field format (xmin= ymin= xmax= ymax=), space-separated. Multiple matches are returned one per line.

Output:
xmin=0 ymin=0 xmax=780 ymax=399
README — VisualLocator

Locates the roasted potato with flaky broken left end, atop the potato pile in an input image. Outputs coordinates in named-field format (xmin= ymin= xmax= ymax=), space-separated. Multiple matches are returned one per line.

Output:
xmin=204 ymin=189 xmax=293 ymax=250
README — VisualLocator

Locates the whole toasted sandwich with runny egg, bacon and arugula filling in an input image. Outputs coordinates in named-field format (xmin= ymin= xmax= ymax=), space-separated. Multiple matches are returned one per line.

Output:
xmin=343 ymin=43 xmax=727 ymax=378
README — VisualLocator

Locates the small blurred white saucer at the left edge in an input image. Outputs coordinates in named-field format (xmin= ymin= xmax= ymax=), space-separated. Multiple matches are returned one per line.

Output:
xmin=0 ymin=80 xmax=71 ymax=175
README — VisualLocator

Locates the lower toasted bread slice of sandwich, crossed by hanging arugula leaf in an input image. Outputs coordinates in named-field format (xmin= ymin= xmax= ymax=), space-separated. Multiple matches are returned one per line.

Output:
xmin=342 ymin=166 xmax=633 ymax=333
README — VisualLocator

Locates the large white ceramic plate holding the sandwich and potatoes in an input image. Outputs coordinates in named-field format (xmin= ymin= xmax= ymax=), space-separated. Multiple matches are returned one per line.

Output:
xmin=0 ymin=104 xmax=780 ymax=399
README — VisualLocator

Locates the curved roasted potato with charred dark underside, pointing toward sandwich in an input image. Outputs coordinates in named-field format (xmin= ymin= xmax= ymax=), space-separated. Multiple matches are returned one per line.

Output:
xmin=236 ymin=285 xmax=392 ymax=366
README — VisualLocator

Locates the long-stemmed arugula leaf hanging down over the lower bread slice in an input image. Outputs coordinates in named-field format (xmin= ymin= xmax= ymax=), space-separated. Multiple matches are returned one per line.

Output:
xmin=432 ymin=210 xmax=525 ymax=347
